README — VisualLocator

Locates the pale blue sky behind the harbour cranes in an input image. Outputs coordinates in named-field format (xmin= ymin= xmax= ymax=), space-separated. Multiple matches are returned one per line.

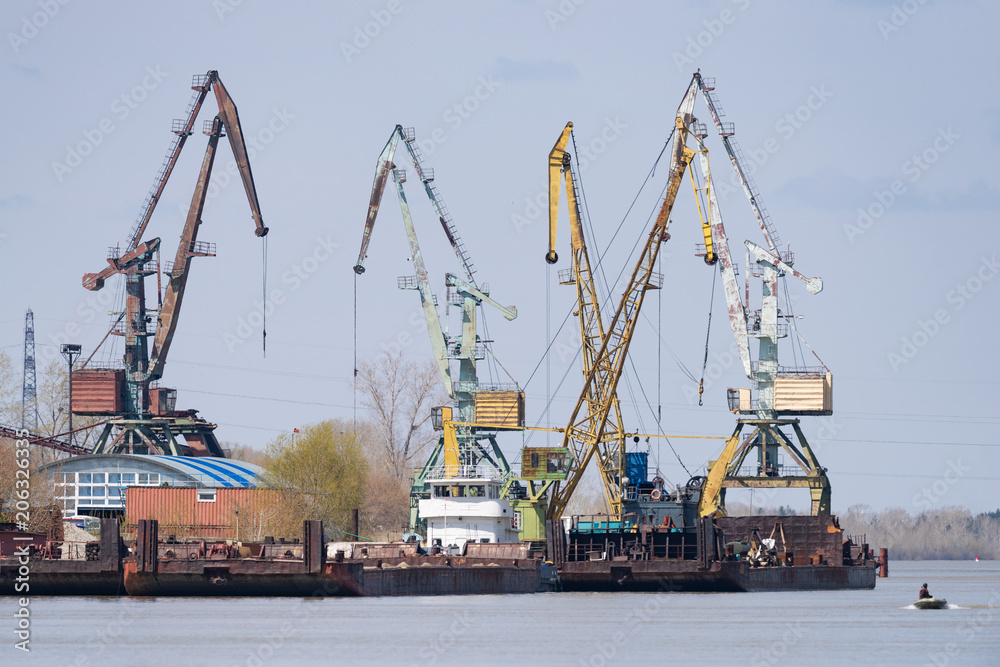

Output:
xmin=0 ymin=0 xmax=1000 ymax=511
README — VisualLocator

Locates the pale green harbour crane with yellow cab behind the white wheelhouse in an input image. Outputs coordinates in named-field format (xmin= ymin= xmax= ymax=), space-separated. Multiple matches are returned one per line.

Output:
xmin=354 ymin=125 xmax=551 ymax=539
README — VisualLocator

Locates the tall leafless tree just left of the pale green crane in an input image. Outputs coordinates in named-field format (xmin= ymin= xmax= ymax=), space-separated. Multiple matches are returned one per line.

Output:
xmin=355 ymin=352 xmax=448 ymax=480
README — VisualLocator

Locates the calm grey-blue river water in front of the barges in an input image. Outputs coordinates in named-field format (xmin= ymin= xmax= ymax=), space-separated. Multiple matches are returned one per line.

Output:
xmin=0 ymin=561 xmax=1000 ymax=667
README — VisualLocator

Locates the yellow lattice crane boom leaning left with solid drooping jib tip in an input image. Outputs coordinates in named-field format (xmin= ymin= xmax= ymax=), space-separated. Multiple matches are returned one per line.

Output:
xmin=545 ymin=123 xmax=625 ymax=513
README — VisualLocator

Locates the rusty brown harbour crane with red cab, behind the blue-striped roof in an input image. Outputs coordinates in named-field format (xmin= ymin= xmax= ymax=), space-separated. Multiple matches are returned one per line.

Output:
xmin=72 ymin=70 xmax=268 ymax=456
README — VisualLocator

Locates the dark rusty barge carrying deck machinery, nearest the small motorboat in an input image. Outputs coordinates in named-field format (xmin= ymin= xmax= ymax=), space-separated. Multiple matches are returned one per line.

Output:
xmin=547 ymin=479 xmax=887 ymax=592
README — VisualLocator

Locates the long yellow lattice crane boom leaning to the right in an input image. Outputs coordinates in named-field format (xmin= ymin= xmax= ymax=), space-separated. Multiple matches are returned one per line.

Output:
xmin=547 ymin=79 xmax=698 ymax=519
